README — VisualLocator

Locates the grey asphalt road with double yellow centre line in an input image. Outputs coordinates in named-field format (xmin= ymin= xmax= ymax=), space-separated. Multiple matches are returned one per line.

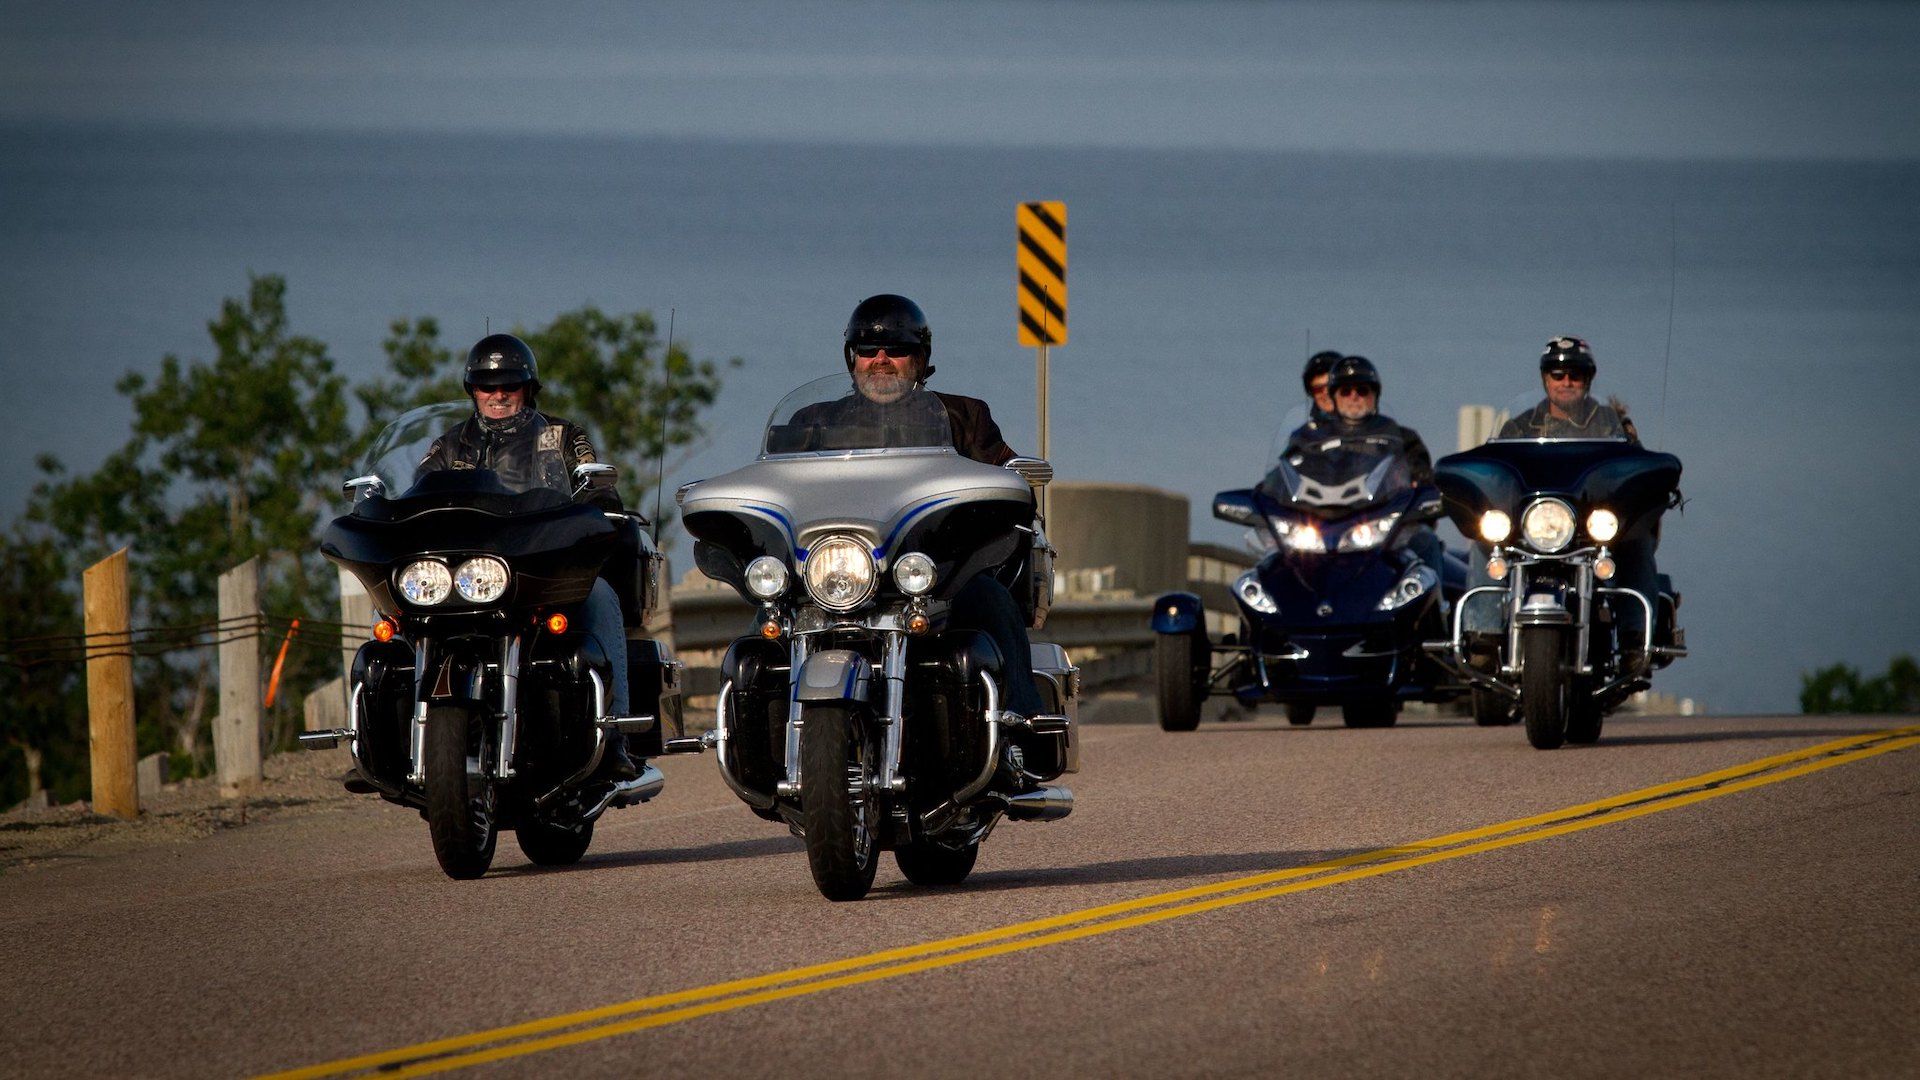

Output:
xmin=0 ymin=713 xmax=1920 ymax=1078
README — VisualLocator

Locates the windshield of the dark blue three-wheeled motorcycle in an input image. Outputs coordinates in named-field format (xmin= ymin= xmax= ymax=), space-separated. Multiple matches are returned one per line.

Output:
xmin=1260 ymin=405 xmax=1413 ymax=515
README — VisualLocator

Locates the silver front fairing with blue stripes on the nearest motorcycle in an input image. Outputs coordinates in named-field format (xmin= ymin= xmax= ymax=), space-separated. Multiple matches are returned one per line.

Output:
xmin=680 ymin=448 xmax=1033 ymax=563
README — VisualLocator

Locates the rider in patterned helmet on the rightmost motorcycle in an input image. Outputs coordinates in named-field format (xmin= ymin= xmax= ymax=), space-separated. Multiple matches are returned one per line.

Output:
xmin=1465 ymin=334 xmax=1659 ymax=673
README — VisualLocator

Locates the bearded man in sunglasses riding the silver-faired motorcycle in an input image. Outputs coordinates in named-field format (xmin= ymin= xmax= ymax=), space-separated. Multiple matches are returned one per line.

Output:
xmin=821 ymin=294 xmax=1044 ymax=717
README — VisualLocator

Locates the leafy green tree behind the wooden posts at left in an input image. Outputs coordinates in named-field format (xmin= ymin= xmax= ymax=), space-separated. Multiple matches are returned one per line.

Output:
xmin=29 ymin=275 xmax=353 ymax=767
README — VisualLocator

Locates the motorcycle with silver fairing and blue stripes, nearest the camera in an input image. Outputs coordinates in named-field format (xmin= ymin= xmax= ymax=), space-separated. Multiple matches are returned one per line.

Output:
xmin=678 ymin=375 xmax=1079 ymax=899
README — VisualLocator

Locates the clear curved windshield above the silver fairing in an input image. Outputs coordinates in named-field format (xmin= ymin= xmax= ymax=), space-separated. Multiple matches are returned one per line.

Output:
xmin=760 ymin=375 xmax=954 ymax=459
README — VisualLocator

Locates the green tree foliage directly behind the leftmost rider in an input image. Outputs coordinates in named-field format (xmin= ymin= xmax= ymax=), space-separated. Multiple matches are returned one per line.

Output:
xmin=355 ymin=306 xmax=741 ymax=525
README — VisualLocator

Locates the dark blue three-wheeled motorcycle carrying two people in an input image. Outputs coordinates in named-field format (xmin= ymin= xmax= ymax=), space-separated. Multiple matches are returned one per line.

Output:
xmin=1152 ymin=417 xmax=1467 ymax=732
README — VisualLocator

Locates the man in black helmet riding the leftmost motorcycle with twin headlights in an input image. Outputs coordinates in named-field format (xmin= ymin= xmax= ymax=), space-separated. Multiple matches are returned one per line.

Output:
xmin=420 ymin=334 xmax=639 ymax=780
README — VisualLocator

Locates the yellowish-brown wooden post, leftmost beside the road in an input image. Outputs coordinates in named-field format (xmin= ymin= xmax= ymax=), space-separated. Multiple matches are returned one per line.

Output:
xmin=81 ymin=548 xmax=140 ymax=817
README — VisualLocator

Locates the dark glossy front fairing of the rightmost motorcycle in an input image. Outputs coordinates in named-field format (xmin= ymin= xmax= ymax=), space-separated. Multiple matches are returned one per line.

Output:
xmin=1434 ymin=440 xmax=1680 ymax=538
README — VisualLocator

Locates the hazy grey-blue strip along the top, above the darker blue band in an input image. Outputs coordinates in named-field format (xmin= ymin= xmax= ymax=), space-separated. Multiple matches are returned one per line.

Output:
xmin=0 ymin=0 xmax=1920 ymax=160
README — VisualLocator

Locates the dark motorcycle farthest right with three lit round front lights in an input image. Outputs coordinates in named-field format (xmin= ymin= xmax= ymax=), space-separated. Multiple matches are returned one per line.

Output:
xmin=1434 ymin=394 xmax=1686 ymax=749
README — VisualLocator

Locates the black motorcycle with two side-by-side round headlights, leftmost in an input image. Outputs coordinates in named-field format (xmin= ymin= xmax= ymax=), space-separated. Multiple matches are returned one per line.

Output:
xmin=300 ymin=404 xmax=680 ymax=878
